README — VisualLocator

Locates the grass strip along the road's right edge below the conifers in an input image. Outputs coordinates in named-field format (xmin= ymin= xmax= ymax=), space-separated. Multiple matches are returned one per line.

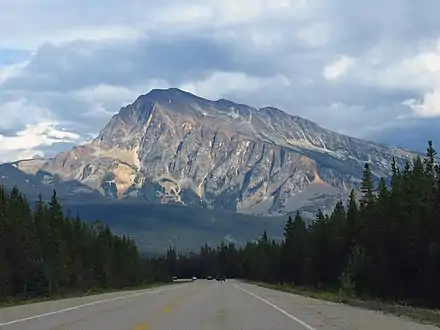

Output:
xmin=245 ymin=281 xmax=440 ymax=327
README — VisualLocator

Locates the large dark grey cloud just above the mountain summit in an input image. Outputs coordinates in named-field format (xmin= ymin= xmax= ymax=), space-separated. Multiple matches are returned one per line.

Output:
xmin=4 ymin=35 xmax=238 ymax=92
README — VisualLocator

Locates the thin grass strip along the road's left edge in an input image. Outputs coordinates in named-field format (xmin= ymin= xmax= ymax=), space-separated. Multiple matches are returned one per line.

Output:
xmin=0 ymin=282 xmax=176 ymax=308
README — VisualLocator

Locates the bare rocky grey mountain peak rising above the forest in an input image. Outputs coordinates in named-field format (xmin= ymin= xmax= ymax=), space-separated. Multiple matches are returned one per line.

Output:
xmin=0 ymin=88 xmax=415 ymax=216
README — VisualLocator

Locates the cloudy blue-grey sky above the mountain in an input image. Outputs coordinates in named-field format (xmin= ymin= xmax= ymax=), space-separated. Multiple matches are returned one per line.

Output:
xmin=0 ymin=0 xmax=440 ymax=161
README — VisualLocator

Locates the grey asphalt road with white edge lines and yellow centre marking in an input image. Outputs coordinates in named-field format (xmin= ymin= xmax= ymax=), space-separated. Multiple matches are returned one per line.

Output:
xmin=0 ymin=280 xmax=439 ymax=330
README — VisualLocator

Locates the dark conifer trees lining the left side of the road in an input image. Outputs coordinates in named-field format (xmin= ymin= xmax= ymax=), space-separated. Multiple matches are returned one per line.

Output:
xmin=0 ymin=186 xmax=144 ymax=300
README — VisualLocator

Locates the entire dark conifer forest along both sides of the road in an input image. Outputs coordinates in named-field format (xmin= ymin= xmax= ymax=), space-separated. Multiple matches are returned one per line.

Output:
xmin=0 ymin=142 xmax=440 ymax=307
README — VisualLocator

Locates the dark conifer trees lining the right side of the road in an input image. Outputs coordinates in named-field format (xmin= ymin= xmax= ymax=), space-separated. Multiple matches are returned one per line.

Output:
xmin=149 ymin=141 xmax=440 ymax=307
